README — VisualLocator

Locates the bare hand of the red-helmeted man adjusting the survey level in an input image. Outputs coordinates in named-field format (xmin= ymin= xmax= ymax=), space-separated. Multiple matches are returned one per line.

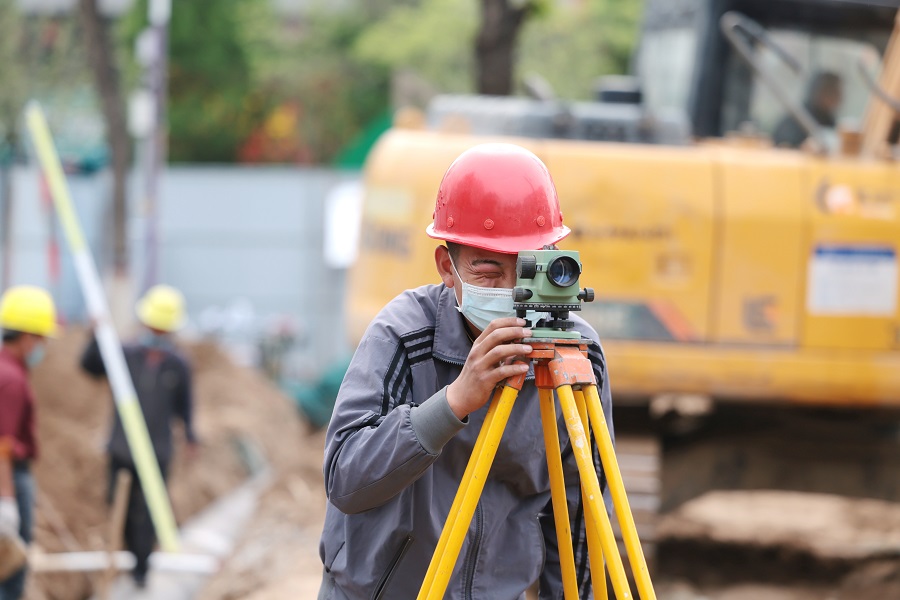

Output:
xmin=447 ymin=317 xmax=531 ymax=420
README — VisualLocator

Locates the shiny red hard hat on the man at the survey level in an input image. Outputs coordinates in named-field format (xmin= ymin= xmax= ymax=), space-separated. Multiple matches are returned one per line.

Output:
xmin=425 ymin=144 xmax=569 ymax=254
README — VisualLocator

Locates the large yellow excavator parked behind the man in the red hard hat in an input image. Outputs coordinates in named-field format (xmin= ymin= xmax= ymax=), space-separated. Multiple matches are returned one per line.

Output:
xmin=348 ymin=0 xmax=900 ymax=510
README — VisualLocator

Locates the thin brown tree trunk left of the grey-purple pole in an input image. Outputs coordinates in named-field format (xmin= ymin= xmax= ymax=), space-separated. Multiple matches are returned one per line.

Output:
xmin=78 ymin=0 xmax=131 ymax=275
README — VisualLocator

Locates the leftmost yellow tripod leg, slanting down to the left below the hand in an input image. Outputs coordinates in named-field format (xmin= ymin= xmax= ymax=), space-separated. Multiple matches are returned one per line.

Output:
xmin=417 ymin=386 xmax=519 ymax=600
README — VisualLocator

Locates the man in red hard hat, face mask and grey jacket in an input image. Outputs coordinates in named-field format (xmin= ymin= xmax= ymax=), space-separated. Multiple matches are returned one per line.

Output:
xmin=319 ymin=144 xmax=612 ymax=600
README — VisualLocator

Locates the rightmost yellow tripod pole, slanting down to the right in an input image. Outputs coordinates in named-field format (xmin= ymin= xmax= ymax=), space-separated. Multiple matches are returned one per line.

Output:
xmin=584 ymin=385 xmax=656 ymax=600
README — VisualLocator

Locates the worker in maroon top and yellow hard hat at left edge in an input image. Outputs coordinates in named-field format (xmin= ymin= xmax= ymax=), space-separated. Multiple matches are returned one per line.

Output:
xmin=0 ymin=286 xmax=56 ymax=600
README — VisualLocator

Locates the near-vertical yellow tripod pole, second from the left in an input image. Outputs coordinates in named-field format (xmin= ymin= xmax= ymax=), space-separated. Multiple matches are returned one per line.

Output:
xmin=539 ymin=388 xmax=578 ymax=600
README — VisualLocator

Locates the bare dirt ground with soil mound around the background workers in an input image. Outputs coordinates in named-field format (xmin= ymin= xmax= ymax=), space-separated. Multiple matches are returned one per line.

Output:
xmin=26 ymin=330 xmax=325 ymax=600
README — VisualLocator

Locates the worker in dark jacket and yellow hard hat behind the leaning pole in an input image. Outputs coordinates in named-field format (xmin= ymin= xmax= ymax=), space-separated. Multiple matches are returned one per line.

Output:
xmin=81 ymin=285 xmax=197 ymax=588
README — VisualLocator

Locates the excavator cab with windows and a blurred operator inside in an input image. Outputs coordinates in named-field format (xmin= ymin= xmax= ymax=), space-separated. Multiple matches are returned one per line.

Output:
xmin=635 ymin=0 xmax=897 ymax=147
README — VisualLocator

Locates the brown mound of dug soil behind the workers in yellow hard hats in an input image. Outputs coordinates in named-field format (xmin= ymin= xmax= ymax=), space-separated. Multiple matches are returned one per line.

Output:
xmin=27 ymin=330 xmax=312 ymax=600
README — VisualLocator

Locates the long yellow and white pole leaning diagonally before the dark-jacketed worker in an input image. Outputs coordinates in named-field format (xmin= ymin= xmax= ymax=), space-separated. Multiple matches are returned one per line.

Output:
xmin=25 ymin=102 xmax=178 ymax=552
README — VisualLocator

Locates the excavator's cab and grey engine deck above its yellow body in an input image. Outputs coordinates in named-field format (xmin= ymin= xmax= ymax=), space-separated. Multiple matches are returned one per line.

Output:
xmin=427 ymin=0 xmax=897 ymax=152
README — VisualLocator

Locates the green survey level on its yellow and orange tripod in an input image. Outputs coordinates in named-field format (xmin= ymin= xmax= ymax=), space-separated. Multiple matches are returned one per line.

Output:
xmin=417 ymin=248 xmax=656 ymax=600
